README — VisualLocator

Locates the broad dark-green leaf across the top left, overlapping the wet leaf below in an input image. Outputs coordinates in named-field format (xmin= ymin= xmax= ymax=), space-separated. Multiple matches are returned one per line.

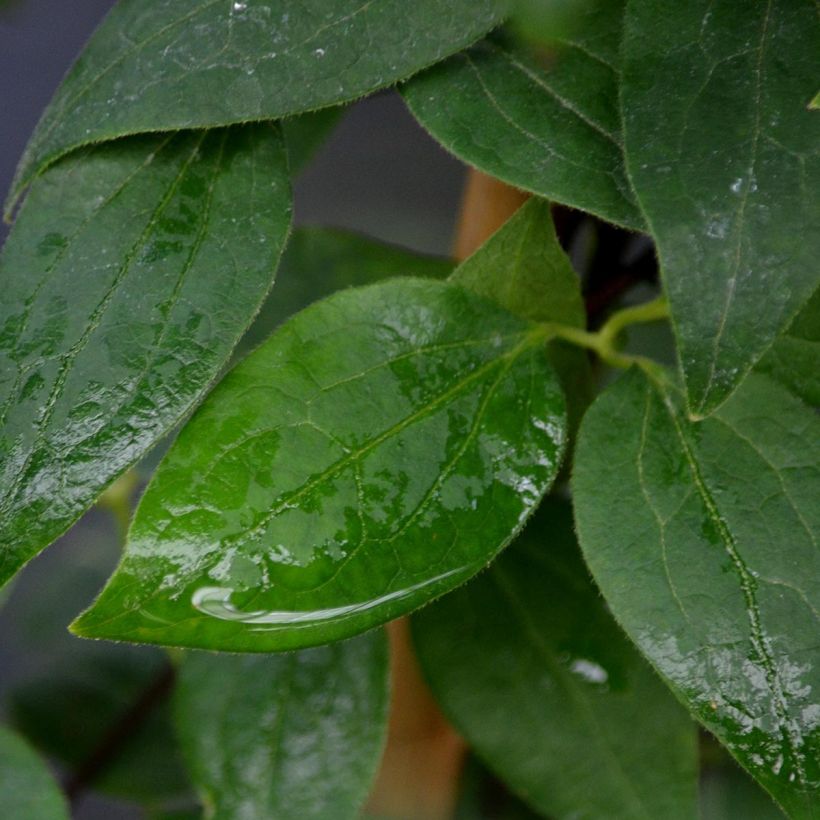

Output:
xmin=12 ymin=0 xmax=502 ymax=205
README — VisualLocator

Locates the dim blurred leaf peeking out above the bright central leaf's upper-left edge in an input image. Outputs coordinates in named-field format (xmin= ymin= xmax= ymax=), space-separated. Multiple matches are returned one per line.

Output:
xmin=238 ymin=227 xmax=453 ymax=351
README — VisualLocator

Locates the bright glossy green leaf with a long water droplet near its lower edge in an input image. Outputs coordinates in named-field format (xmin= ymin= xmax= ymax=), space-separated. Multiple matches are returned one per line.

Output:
xmin=74 ymin=279 xmax=565 ymax=652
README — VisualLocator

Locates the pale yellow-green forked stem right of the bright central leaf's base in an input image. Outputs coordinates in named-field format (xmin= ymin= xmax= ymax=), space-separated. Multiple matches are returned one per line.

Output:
xmin=543 ymin=296 xmax=669 ymax=379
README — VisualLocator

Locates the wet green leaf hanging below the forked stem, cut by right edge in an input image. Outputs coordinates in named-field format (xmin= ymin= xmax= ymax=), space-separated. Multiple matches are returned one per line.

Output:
xmin=573 ymin=371 xmax=820 ymax=818
